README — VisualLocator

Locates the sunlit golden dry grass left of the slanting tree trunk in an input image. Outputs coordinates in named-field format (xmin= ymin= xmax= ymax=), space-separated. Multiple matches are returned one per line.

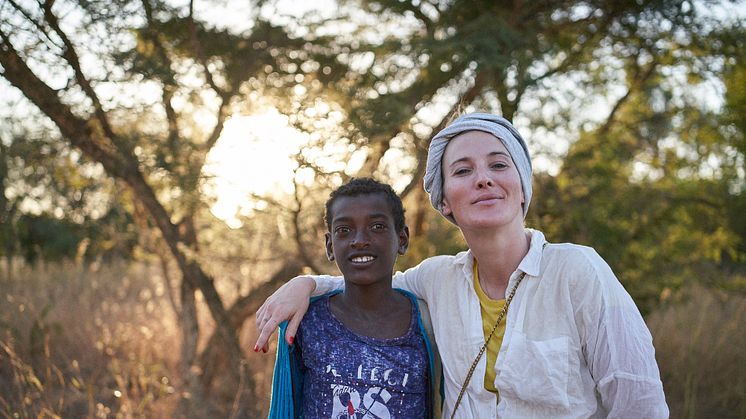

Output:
xmin=0 ymin=264 xmax=178 ymax=418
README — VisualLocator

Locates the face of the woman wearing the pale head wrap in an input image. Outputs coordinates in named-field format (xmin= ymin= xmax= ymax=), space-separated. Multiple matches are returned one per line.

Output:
xmin=442 ymin=131 xmax=523 ymax=230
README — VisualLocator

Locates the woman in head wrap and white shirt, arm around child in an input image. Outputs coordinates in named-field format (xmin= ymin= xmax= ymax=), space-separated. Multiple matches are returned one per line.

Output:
xmin=255 ymin=113 xmax=668 ymax=418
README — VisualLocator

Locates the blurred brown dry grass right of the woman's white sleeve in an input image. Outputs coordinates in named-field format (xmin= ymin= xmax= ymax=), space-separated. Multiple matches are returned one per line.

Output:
xmin=647 ymin=287 xmax=746 ymax=419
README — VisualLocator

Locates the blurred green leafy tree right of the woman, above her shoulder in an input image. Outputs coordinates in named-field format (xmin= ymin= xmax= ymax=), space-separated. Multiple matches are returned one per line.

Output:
xmin=534 ymin=13 xmax=744 ymax=312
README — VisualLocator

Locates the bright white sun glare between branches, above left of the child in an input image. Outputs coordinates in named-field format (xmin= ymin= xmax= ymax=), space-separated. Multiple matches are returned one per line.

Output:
xmin=205 ymin=111 xmax=307 ymax=228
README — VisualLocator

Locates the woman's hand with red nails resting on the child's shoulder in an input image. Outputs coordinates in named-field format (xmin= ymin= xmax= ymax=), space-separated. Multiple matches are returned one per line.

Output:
xmin=254 ymin=276 xmax=316 ymax=352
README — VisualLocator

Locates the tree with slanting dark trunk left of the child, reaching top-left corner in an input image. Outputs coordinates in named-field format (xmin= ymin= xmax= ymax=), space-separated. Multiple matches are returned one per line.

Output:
xmin=0 ymin=0 xmax=302 ymax=415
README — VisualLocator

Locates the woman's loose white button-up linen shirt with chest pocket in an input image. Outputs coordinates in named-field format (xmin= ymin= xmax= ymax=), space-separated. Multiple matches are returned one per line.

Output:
xmin=314 ymin=230 xmax=668 ymax=418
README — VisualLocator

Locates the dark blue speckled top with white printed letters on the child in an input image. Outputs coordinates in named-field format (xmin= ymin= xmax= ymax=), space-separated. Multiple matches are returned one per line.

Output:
xmin=297 ymin=296 xmax=429 ymax=419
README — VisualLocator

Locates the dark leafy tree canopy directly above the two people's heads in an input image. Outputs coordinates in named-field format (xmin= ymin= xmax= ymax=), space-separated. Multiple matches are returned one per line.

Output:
xmin=258 ymin=1 xmax=732 ymax=244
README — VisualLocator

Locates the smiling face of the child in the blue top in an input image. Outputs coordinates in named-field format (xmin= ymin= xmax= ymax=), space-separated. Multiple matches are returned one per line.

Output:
xmin=326 ymin=193 xmax=409 ymax=285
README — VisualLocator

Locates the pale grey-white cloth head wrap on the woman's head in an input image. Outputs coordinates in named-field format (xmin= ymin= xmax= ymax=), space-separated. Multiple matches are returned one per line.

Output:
xmin=425 ymin=113 xmax=531 ymax=224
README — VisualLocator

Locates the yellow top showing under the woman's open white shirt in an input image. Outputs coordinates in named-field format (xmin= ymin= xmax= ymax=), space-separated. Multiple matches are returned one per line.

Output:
xmin=473 ymin=259 xmax=505 ymax=394
